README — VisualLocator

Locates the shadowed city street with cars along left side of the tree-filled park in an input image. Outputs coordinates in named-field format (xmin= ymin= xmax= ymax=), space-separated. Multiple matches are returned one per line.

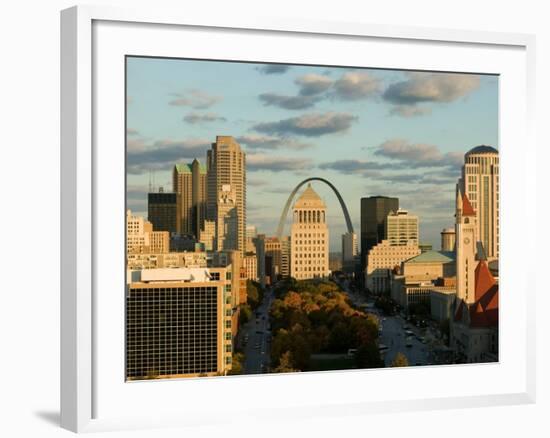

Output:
xmin=243 ymin=288 xmax=273 ymax=374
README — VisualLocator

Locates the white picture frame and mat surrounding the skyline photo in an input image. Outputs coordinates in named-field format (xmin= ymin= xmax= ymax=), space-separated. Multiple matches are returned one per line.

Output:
xmin=61 ymin=6 xmax=536 ymax=432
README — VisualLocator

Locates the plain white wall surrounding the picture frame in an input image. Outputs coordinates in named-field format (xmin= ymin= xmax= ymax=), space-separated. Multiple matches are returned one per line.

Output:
xmin=0 ymin=0 xmax=550 ymax=438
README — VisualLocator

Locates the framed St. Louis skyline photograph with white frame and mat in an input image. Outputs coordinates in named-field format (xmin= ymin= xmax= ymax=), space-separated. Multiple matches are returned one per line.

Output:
xmin=61 ymin=6 xmax=537 ymax=432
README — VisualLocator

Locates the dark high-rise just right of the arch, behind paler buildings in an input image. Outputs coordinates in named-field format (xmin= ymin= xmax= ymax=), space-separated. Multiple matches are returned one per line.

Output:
xmin=361 ymin=196 xmax=399 ymax=270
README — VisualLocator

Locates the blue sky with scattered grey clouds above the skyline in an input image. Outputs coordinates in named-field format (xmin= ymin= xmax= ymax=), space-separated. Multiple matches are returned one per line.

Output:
xmin=127 ymin=57 xmax=498 ymax=251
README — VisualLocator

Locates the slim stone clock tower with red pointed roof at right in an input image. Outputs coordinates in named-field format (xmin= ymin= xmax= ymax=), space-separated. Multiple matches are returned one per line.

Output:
xmin=455 ymin=189 xmax=477 ymax=304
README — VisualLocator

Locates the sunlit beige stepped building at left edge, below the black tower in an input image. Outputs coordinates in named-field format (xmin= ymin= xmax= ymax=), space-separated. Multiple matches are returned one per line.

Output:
xmin=126 ymin=210 xmax=170 ymax=254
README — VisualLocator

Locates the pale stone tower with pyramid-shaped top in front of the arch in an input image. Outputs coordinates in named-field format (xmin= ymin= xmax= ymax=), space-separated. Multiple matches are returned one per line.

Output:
xmin=290 ymin=184 xmax=329 ymax=280
